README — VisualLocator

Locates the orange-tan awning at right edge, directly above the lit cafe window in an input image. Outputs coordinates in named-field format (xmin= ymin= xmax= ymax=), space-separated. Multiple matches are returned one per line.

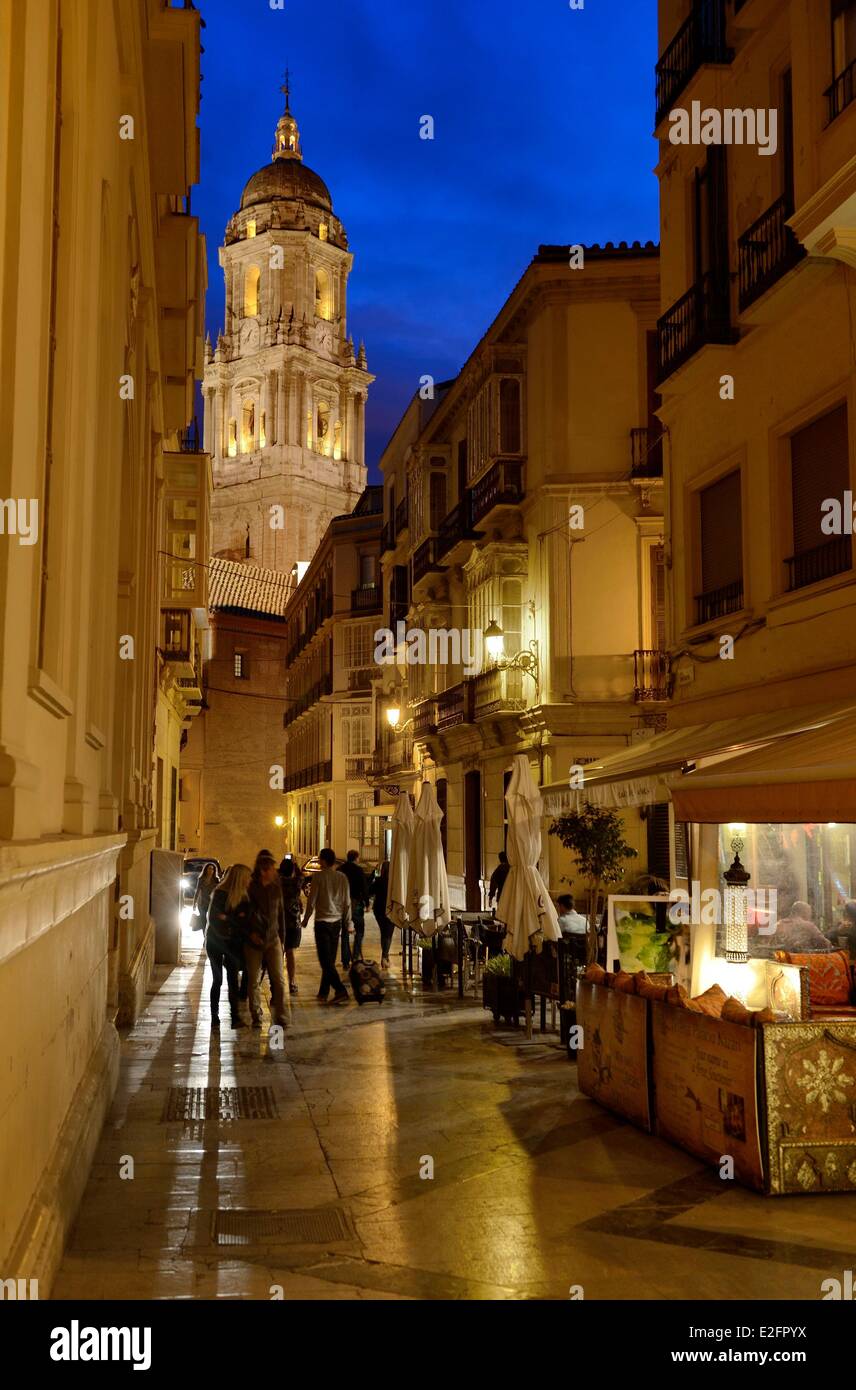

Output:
xmin=670 ymin=710 xmax=856 ymax=824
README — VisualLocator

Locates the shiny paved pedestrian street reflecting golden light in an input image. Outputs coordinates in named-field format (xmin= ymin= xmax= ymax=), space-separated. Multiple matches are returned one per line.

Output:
xmin=53 ymin=919 xmax=850 ymax=1300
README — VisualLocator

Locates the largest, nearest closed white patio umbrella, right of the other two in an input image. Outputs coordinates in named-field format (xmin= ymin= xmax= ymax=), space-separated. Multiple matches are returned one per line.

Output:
xmin=496 ymin=753 xmax=561 ymax=960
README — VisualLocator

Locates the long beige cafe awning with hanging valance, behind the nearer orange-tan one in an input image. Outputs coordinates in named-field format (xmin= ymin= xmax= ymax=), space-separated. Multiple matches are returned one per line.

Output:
xmin=542 ymin=703 xmax=856 ymax=821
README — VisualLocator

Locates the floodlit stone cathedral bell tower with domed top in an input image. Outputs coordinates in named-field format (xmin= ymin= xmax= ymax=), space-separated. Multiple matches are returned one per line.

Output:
xmin=203 ymin=76 xmax=374 ymax=573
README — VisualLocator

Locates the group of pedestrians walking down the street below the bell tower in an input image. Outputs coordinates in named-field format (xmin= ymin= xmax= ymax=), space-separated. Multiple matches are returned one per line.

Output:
xmin=193 ymin=849 xmax=395 ymax=1029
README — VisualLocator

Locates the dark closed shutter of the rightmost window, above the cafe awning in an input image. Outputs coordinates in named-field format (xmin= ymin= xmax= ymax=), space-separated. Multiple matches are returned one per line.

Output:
xmin=791 ymin=406 xmax=850 ymax=555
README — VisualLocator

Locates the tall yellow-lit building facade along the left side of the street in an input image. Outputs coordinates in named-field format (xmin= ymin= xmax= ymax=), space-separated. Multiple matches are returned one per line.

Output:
xmin=0 ymin=0 xmax=206 ymax=1297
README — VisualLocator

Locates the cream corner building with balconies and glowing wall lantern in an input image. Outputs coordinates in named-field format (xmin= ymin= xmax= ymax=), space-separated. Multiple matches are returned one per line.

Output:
xmin=372 ymin=245 xmax=668 ymax=910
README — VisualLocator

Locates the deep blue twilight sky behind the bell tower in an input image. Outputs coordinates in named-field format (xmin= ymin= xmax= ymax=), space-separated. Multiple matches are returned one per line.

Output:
xmin=193 ymin=0 xmax=659 ymax=481
